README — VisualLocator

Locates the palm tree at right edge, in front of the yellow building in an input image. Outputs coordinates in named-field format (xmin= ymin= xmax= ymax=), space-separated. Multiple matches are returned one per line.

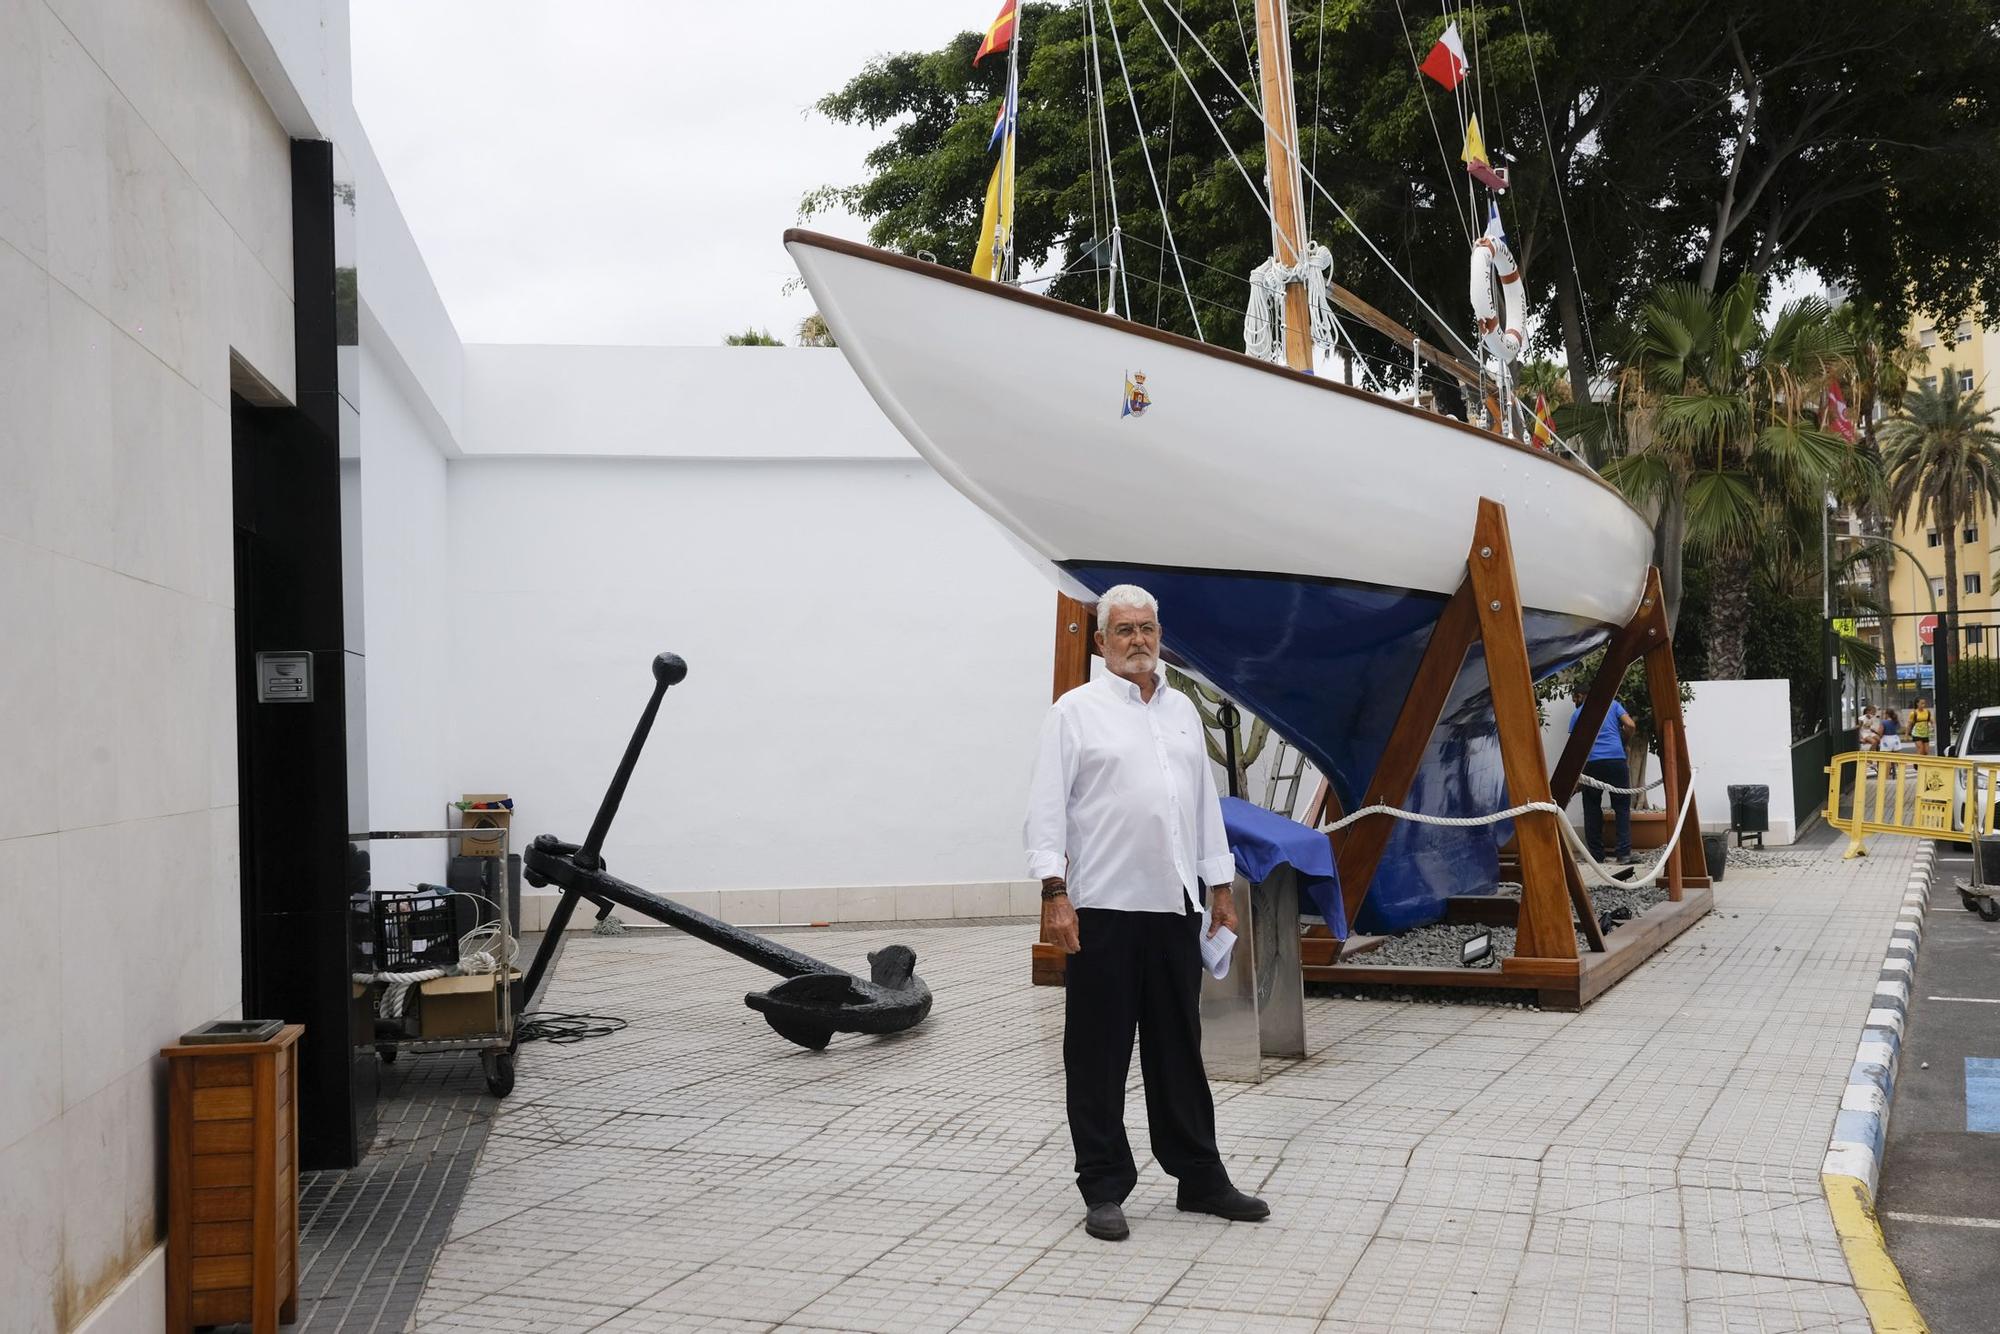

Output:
xmin=1882 ymin=376 xmax=2000 ymax=674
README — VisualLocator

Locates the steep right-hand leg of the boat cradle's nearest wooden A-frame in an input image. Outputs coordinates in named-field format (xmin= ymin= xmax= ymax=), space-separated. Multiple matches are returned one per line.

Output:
xmin=1466 ymin=498 xmax=1588 ymax=966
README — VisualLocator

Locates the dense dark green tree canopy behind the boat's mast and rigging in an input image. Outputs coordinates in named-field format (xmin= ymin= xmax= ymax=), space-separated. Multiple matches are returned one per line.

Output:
xmin=802 ymin=0 xmax=2000 ymax=396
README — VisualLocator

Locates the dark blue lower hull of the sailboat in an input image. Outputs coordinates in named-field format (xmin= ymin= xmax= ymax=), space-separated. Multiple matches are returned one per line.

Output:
xmin=1062 ymin=560 xmax=1612 ymax=934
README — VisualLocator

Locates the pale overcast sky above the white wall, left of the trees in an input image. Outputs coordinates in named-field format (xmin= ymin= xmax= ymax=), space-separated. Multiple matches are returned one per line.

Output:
xmin=352 ymin=0 xmax=976 ymax=344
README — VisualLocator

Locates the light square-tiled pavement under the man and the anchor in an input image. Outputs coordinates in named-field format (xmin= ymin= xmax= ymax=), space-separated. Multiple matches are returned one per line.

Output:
xmin=414 ymin=838 xmax=1914 ymax=1334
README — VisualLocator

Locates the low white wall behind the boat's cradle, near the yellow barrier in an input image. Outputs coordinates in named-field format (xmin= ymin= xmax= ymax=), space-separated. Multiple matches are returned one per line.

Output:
xmin=1542 ymin=680 xmax=1798 ymax=846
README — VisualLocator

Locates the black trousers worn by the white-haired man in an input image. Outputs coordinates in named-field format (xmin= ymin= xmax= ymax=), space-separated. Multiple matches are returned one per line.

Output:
xmin=1062 ymin=908 xmax=1230 ymax=1204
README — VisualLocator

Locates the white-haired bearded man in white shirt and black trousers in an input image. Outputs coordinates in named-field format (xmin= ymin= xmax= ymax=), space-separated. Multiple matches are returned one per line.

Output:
xmin=1022 ymin=584 xmax=1270 ymax=1242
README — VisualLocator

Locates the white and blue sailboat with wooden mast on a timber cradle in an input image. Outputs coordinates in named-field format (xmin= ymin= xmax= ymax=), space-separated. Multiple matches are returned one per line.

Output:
xmin=786 ymin=0 xmax=1652 ymax=932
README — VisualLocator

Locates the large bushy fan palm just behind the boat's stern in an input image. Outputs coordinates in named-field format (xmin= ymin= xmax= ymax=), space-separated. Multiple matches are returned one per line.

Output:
xmin=1604 ymin=274 xmax=1864 ymax=680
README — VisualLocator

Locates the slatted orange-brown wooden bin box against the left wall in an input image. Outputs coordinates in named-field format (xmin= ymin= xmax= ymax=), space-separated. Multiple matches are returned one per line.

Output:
xmin=160 ymin=1024 xmax=306 ymax=1334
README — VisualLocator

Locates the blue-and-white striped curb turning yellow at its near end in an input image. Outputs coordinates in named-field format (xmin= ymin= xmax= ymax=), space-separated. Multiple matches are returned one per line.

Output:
xmin=1820 ymin=840 xmax=1938 ymax=1334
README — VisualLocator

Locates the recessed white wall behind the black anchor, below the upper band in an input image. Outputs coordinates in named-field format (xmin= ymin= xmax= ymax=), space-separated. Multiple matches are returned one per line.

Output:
xmin=448 ymin=454 xmax=1054 ymax=920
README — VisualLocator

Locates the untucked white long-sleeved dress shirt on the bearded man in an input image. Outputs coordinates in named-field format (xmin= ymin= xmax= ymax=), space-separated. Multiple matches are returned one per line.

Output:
xmin=1022 ymin=672 xmax=1236 ymax=912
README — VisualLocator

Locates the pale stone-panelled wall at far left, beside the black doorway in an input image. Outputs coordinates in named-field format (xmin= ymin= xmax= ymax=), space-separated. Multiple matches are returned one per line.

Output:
xmin=0 ymin=0 xmax=294 ymax=1330
